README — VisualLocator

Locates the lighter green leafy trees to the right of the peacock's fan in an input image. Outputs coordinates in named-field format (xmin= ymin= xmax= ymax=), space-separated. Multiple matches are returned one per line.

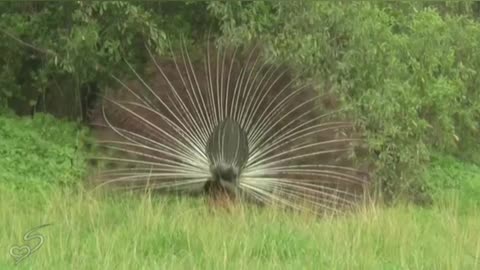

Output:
xmin=209 ymin=1 xmax=480 ymax=202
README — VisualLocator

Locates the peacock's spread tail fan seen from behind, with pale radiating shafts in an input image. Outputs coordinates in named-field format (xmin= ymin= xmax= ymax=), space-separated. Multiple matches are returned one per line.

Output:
xmin=87 ymin=39 xmax=368 ymax=215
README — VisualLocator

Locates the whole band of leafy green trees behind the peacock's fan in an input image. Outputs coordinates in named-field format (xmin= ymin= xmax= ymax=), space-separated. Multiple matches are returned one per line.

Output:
xmin=0 ymin=1 xmax=480 ymax=206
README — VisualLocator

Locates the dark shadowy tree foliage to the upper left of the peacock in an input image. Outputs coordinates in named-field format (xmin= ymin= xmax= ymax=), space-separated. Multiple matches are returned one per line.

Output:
xmin=0 ymin=1 xmax=212 ymax=117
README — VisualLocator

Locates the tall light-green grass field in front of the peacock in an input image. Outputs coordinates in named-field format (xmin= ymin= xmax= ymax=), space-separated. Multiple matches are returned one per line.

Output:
xmin=0 ymin=114 xmax=480 ymax=270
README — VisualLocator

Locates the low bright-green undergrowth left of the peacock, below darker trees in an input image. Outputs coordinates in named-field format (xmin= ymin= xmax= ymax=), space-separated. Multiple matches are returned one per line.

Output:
xmin=0 ymin=114 xmax=87 ymax=190
